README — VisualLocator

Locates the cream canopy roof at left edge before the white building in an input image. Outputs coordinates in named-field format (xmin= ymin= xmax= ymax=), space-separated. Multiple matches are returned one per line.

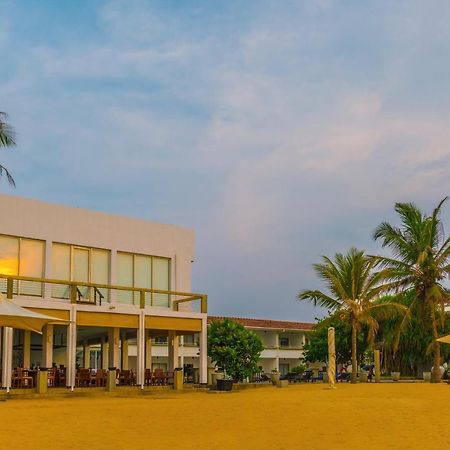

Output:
xmin=0 ymin=293 xmax=66 ymax=333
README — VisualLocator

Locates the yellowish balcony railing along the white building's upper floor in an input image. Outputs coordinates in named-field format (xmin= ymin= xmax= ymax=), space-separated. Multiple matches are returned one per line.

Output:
xmin=0 ymin=274 xmax=208 ymax=314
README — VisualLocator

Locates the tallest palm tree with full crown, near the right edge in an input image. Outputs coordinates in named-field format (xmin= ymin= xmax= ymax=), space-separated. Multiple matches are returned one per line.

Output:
xmin=373 ymin=197 xmax=450 ymax=383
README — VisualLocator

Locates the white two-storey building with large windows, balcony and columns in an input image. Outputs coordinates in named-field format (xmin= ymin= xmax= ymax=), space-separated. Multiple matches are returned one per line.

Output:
xmin=0 ymin=195 xmax=207 ymax=387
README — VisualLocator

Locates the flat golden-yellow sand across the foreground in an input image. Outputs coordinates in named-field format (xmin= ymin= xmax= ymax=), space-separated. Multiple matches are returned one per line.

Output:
xmin=0 ymin=383 xmax=450 ymax=450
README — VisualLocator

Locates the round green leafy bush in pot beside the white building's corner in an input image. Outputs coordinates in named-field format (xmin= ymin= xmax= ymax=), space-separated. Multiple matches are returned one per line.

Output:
xmin=208 ymin=319 xmax=264 ymax=381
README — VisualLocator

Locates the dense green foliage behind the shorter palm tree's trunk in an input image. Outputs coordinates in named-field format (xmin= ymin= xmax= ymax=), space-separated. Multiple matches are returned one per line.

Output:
xmin=304 ymin=313 xmax=368 ymax=364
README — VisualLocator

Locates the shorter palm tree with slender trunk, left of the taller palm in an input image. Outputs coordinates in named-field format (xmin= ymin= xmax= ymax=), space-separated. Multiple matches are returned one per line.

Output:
xmin=298 ymin=248 xmax=404 ymax=383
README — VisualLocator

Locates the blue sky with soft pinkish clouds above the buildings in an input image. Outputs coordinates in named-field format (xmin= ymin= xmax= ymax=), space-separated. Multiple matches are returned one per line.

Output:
xmin=0 ymin=0 xmax=450 ymax=321
